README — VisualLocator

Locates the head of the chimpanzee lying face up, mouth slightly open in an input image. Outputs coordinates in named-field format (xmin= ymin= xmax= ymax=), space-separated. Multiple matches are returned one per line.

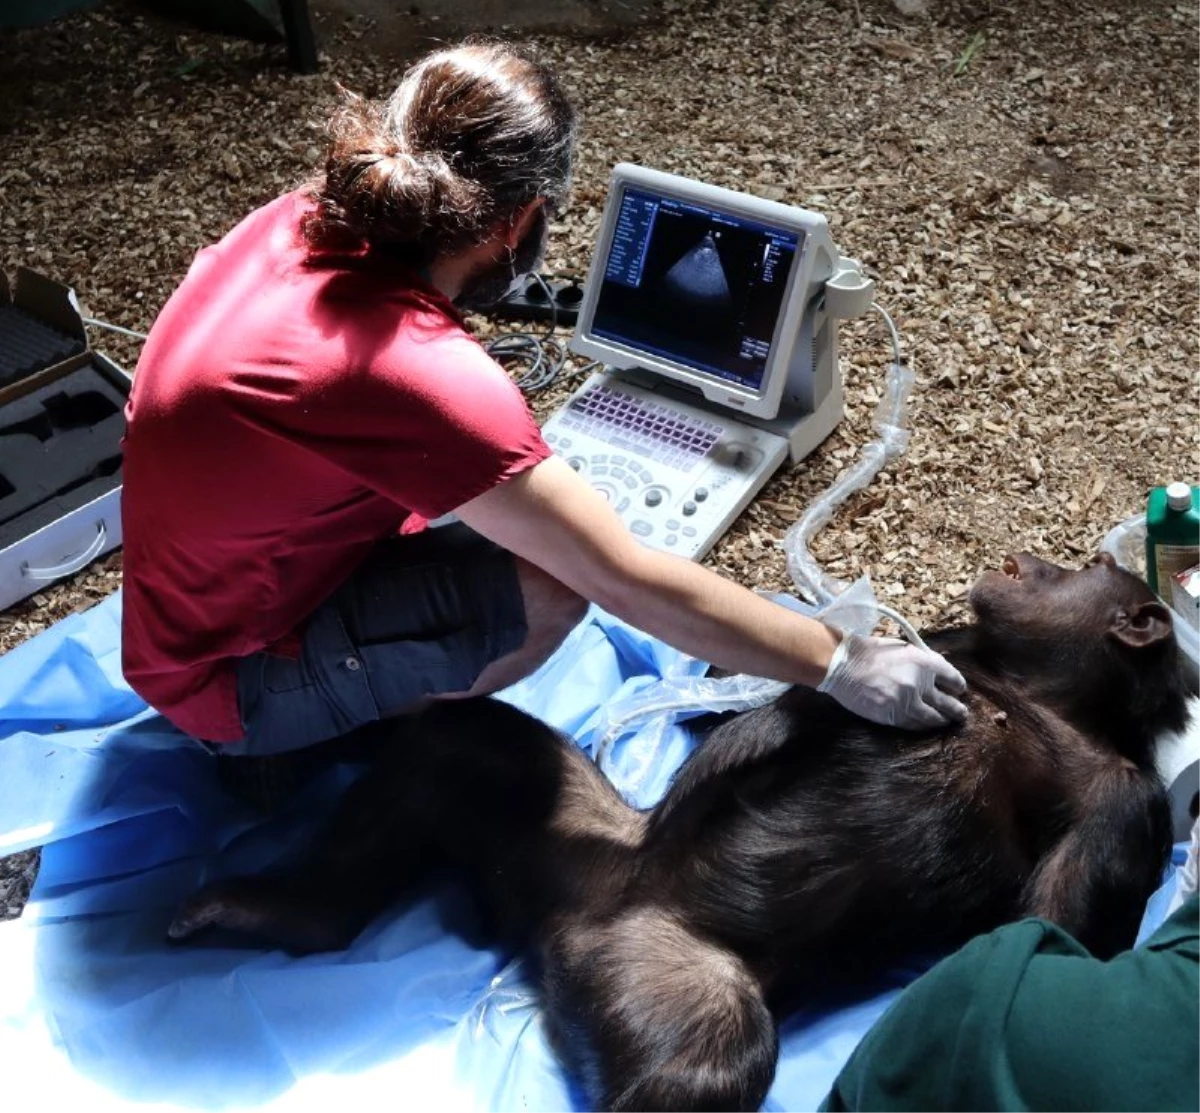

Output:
xmin=970 ymin=553 xmax=1187 ymax=757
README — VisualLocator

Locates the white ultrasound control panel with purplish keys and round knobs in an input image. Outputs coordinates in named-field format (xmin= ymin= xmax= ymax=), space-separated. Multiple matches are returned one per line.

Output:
xmin=542 ymin=372 xmax=787 ymax=560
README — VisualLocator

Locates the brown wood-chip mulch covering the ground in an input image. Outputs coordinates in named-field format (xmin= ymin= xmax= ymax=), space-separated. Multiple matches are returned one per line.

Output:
xmin=0 ymin=0 xmax=1200 ymax=915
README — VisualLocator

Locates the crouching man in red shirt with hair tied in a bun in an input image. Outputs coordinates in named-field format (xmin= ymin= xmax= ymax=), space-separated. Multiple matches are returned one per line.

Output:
xmin=124 ymin=43 xmax=965 ymax=772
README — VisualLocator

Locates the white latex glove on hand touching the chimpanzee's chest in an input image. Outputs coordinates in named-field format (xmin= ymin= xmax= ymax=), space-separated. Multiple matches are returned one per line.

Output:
xmin=817 ymin=633 xmax=967 ymax=730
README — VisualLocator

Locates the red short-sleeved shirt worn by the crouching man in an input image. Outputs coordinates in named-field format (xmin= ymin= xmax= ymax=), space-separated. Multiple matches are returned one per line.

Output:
xmin=122 ymin=193 xmax=550 ymax=742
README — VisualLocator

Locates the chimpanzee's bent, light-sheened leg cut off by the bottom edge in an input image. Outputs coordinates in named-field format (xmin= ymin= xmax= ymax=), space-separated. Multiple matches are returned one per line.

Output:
xmin=542 ymin=907 xmax=779 ymax=1113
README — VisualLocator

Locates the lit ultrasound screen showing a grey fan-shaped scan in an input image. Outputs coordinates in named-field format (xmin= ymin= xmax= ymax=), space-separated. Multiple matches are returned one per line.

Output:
xmin=590 ymin=189 xmax=802 ymax=390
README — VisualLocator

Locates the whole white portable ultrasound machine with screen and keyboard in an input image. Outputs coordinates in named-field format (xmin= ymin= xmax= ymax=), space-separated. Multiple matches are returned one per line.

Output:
xmin=544 ymin=163 xmax=874 ymax=560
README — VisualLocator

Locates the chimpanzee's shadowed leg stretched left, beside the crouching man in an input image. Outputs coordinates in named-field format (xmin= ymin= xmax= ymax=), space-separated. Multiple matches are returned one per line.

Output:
xmin=170 ymin=699 xmax=595 ymax=950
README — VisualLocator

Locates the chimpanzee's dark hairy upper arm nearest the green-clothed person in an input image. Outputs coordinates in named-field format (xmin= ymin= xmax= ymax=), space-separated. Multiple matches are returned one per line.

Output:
xmin=1025 ymin=758 xmax=1171 ymax=958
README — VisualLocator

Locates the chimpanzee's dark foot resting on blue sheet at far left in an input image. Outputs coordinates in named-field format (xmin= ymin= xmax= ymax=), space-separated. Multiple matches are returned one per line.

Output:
xmin=167 ymin=878 xmax=364 ymax=955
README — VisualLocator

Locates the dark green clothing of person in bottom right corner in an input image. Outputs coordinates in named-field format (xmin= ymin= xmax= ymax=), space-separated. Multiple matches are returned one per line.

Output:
xmin=822 ymin=900 xmax=1200 ymax=1113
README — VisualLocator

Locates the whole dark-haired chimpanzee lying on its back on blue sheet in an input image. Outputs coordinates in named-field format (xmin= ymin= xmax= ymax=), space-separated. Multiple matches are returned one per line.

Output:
xmin=169 ymin=554 xmax=1187 ymax=1113
